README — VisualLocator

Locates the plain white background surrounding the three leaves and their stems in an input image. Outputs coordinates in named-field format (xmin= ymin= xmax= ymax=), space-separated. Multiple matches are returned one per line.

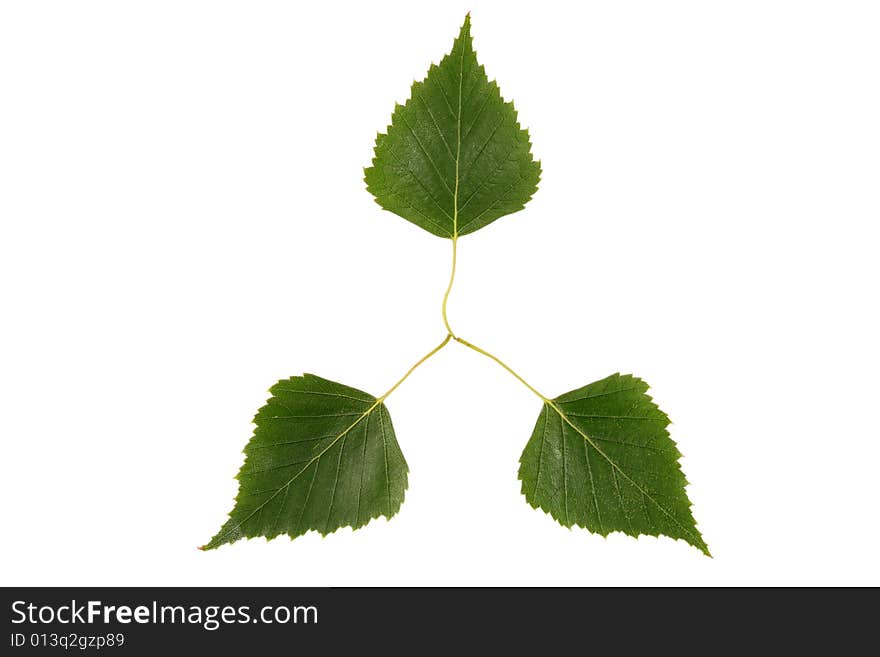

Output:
xmin=0 ymin=0 xmax=880 ymax=585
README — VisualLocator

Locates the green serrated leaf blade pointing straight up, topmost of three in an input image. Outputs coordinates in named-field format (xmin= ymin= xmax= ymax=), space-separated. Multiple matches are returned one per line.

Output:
xmin=365 ymin=15 xmax=541 ymax=238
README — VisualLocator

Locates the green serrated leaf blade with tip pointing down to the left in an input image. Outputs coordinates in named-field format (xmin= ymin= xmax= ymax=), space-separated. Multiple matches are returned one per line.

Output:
xmin=203 ymin=374 xmax=408 ymax=549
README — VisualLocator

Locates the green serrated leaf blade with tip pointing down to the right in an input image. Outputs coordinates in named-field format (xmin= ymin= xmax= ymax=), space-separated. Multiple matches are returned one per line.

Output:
xmin=519 ymin=374 xmax=709 ymax=555
